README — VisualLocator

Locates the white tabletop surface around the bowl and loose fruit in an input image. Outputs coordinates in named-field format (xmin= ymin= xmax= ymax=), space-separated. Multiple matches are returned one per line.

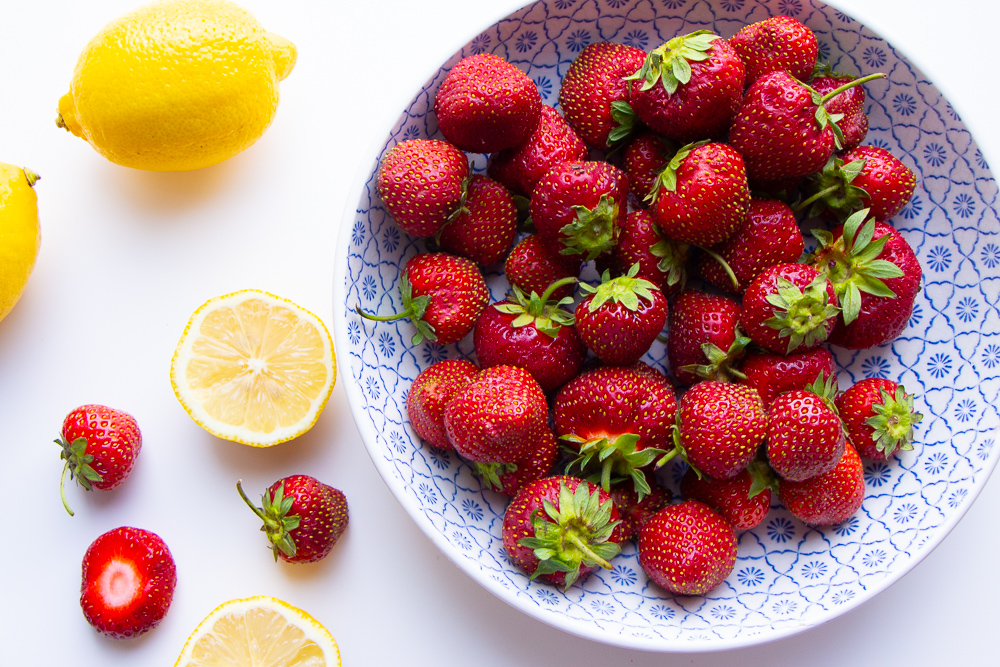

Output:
xmin=0 ymin=0 xmax=1000 ymax=667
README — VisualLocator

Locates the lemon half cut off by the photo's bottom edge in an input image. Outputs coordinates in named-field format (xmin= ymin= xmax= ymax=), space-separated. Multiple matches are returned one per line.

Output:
xmin=174 ymin=595 xmax=340 ymax=667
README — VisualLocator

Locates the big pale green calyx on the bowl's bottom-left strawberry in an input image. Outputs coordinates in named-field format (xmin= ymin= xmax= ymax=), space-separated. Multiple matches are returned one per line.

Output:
xmin=518 ymin=483 xmax=621 ymax=589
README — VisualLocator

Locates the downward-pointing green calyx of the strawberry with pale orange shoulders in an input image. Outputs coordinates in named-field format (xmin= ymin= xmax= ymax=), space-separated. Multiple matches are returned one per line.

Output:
xmin=561 ymin=433 xmax=667 ymax=500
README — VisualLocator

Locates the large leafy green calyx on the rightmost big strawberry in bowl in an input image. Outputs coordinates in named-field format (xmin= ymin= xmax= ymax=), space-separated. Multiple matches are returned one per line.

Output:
xmin=811 ymin=208 xmax=904 ymax=324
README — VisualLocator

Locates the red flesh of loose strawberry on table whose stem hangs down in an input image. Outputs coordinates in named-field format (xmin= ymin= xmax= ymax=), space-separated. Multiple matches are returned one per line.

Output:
xmin=62 ymin=404 xmax=142 ymax=491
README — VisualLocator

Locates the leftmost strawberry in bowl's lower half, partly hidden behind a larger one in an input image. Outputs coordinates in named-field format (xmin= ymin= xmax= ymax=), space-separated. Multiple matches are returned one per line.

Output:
xmin=406 ymin=359 xmax=479 ymax=449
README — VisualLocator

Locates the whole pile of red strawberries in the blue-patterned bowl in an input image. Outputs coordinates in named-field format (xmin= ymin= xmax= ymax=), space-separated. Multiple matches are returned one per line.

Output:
xmin=358 ymin=16 xmax=921 ymax=595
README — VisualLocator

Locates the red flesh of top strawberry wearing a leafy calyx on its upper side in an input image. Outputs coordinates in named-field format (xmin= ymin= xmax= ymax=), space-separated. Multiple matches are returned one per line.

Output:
xmin=629 ymin=38 xmax=745 ymax=143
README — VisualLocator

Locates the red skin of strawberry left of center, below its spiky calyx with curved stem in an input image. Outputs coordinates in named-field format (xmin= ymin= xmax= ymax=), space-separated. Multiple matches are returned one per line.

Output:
xmin=472 ymin=299 xmax=587 ymax=393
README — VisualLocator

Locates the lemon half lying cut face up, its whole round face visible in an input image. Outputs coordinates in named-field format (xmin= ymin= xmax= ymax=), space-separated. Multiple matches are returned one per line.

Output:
xmin=170 ymin=290 xmax=337 ymax=447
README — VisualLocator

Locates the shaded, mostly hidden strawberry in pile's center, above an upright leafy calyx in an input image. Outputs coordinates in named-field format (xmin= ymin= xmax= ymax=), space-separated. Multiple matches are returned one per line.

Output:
xmin=596 ymin=209 xmax=688 ymax=296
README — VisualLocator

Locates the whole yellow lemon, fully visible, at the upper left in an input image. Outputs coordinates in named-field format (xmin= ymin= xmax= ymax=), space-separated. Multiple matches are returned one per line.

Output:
xmin=56 ymin=0 xmax=296 ymax=171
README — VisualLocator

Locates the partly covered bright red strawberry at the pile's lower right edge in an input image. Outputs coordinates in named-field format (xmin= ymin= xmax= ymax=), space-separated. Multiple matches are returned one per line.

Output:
xmin=778 ymin=442 xmax=865 ymax=526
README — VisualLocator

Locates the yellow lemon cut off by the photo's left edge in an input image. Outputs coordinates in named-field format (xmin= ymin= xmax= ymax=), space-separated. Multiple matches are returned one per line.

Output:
xmin=0 ymin=162 xmax=42 ymax=320
